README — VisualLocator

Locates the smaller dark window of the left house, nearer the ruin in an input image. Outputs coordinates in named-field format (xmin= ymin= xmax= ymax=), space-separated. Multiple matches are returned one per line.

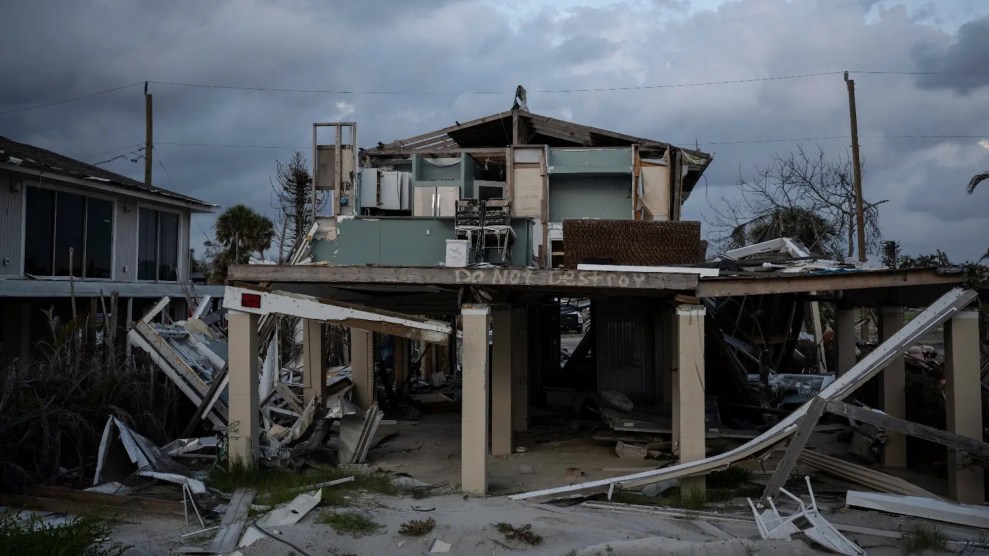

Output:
xmin=137 ymin=208 xmax=179 ymax=282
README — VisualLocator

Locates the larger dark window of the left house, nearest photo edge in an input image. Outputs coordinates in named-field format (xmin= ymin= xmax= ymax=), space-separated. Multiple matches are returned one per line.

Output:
xmin=24 ymin=187 xmax=113 ymax=278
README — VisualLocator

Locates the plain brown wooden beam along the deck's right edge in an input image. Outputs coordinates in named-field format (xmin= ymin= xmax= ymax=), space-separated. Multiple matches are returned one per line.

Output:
xmin=697 ymin=269 xmax=965 ymax=297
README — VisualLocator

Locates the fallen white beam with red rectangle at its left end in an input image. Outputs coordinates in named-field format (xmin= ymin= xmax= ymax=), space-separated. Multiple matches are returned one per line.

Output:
xmin=223 ymin=284 xmax=451 ymax=344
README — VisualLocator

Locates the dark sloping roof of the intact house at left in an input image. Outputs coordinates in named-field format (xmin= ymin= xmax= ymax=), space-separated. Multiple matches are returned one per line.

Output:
xmin=0 ymin=136 xmax=216 ymax=212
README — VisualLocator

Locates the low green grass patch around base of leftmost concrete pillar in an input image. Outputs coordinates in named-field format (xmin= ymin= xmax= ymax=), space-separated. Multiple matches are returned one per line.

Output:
xmin=207 ymin=464 xmax=402 ymax=506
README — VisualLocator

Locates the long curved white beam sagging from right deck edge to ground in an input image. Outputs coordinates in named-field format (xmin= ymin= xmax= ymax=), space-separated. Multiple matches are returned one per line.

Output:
xmin=510 ymin=288 xmax=977 ymax=500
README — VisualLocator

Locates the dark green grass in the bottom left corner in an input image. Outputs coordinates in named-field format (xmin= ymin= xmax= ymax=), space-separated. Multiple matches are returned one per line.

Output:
xmin=0 ymin=512 xmax=129 ymax=556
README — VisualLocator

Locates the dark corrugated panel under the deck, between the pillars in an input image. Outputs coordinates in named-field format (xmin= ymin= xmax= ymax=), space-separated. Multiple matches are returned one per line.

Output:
xmin=592 ymin=299 xmax=658 ymax=403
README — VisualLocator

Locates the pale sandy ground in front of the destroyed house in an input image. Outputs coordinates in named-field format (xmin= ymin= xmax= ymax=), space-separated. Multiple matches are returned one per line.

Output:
xmin=114 ymin=488 xmax=986 ymax=556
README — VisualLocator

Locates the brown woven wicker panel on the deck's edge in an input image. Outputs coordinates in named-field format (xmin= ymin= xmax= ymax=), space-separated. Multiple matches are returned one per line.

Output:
xmin=563 ymin=220 xmax=701 ymax=268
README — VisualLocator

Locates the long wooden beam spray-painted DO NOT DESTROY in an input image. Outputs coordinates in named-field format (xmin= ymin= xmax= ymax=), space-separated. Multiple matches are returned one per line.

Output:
xmin=226 ymin=265 xmax=698 ymax=294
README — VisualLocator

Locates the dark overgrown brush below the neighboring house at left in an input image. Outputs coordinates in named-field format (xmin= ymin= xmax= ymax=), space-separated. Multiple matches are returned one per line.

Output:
xmin=0 ymin=312 xmax=188 ymax=492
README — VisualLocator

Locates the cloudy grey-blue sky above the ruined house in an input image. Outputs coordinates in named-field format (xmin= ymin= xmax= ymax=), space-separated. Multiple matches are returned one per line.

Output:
xmin=0 ymin=0 xmax=989 ymax=260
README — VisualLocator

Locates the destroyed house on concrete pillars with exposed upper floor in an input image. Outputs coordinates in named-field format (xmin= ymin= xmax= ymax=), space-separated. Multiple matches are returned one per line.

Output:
xmin=224 ymin=109 xmax=983 ymax=502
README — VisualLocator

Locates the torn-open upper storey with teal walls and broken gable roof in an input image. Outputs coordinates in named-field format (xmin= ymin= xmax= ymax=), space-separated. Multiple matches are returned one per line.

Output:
xmin=313 ymin=110 xmax=712 ymax=268
